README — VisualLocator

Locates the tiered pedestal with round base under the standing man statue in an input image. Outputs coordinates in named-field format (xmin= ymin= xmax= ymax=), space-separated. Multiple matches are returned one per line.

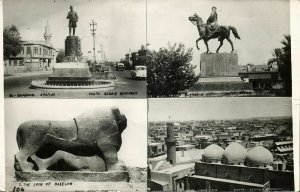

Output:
xmin=31 ymin=36 xmax=115 ymax=91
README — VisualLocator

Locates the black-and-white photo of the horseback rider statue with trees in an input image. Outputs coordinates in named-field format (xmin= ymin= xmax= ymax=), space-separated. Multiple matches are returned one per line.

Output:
xmin=147 ymin=0 xmax=292 ymax=97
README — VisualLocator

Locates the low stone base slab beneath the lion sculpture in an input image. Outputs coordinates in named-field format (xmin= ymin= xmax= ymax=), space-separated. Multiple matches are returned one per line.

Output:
xmin=15 ymin=171 xmax=130 ymax=182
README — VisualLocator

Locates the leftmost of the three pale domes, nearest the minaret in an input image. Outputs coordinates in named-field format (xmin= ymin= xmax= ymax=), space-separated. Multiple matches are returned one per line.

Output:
xmin=202 ymin=144 xmax=224 ymax=161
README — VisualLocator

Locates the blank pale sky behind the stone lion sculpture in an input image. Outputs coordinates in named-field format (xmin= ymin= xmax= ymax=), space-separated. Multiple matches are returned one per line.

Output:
xmin=5 ymin=99 xmax=147 ymax=167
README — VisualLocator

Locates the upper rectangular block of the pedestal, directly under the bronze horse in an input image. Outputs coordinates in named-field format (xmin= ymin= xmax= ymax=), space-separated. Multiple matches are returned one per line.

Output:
xmin=200 ymin=53 xmax=239 ymax=77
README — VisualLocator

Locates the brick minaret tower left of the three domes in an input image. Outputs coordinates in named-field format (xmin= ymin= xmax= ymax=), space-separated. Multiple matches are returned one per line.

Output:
xmin=166 ymin=118 xmax=176 ymax=165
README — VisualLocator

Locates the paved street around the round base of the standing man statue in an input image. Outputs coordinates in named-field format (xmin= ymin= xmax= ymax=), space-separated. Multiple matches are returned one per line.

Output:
xmin=4 ymin=71 xmax=146 ymax=98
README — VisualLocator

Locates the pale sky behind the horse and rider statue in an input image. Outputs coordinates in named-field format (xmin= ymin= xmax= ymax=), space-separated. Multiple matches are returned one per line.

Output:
xmin=147 ymin=0 xmax=290 ymax=73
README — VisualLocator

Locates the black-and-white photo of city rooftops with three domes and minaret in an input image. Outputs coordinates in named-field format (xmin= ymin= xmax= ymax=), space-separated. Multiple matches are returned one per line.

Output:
xmin=148 ymin=97 xmax=292 ymax=191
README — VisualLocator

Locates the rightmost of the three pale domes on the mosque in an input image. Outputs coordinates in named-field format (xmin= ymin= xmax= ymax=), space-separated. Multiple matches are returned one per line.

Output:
xmin=246 ymin=146 xmax=273 ymax=166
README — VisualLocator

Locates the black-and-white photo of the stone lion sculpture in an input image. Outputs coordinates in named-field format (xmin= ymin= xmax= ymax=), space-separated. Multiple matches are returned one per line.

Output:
xmin=5 ymin=99 xmax=147 ymax=192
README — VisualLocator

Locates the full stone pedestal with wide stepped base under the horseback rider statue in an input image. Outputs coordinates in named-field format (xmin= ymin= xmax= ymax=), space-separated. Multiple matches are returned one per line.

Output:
xmin=189 ymin=53 xmax=254 ymax=96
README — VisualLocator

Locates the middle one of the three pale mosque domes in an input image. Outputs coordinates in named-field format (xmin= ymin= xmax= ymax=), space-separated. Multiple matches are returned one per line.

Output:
xmin=223 ymin=142 xmax=247 ymax=165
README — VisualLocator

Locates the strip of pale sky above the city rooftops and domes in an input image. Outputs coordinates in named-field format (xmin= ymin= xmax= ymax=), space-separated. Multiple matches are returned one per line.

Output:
xmin=148 ymin=97 xmax=292 ymax=121
